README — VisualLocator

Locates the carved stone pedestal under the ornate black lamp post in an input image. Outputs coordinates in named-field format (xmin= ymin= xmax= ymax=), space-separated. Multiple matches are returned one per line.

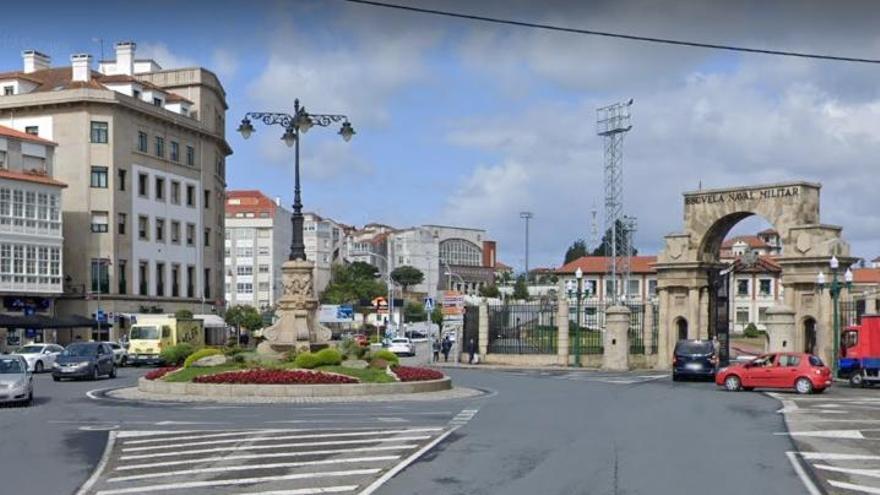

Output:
xmin=257 ymin=260 xmax=331 ymax=358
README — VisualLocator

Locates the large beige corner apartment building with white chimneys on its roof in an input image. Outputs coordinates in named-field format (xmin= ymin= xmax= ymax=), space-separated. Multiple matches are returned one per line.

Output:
xmin=0 ymin=42 xmax=232 ymax=338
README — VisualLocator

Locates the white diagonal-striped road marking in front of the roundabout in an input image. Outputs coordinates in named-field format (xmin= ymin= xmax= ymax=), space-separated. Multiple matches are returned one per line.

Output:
xmin=78 ymin=426 xmax=450 ymax=495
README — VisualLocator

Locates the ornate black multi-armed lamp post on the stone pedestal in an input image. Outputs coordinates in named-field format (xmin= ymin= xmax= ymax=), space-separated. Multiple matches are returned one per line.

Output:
xmin=238 ymin=99 xmax=355 ymax=261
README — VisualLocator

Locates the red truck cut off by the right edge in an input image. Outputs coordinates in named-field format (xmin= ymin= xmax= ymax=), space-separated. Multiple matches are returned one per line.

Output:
xmin=837 ymin=315 xmax=880 ymax=387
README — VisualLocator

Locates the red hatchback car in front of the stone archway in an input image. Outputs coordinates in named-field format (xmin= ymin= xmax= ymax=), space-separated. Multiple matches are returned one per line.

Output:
xmin=715 ymin=352 xmax=831 ymax=394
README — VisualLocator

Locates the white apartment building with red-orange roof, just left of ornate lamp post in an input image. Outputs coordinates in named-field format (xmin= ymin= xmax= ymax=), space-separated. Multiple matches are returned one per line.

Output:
xmin=224 ymin=190 xmax=293 ymax=311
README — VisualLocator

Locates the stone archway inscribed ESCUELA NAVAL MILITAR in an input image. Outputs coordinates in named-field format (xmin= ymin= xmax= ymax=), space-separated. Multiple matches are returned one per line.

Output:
xmin=656 ymin=182 xmax=855 ymax=369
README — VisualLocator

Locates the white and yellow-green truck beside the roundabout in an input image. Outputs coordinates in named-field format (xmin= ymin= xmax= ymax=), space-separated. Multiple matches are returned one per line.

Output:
xmin=128 ymin=314 xmax=205 ymax=366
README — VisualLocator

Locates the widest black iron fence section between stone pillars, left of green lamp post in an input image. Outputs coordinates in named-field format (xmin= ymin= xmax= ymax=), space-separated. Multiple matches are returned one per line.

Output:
xmin=488 ymin=302 xmax=557 ymax=354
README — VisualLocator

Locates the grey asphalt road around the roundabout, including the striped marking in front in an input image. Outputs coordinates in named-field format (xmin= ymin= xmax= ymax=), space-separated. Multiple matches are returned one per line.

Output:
xmin=0 ymin=354 xmax=805 ymax=495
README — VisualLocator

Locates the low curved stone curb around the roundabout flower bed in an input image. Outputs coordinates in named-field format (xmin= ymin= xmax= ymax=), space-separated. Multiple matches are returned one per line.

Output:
xmin=138 ymin=376 xmax=452 ymax=397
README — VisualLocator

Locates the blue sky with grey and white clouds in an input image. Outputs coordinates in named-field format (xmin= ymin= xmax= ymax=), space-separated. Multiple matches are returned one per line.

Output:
xmin=0 ymin=0 xmax=880 ymax=268
